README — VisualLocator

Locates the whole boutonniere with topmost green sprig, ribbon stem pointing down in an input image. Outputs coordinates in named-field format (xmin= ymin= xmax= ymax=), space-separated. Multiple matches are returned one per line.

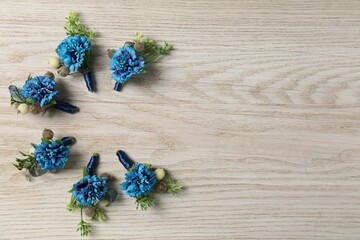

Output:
xmin=49 ymin=12 xmax=95 ymax=92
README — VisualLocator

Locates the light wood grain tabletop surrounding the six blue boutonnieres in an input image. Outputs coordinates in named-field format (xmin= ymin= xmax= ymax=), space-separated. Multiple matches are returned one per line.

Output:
xmin=0 ymin=0 xmax=360 ymax=240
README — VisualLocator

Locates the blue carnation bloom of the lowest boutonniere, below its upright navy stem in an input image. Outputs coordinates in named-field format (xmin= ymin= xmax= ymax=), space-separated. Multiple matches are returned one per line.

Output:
xmin=72 ymin=175 xmax=108 ymax=207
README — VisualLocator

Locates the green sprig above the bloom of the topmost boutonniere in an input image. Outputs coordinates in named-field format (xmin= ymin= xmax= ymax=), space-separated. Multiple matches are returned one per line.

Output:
xmin=64 ymin=11 xmax=95 ymax=42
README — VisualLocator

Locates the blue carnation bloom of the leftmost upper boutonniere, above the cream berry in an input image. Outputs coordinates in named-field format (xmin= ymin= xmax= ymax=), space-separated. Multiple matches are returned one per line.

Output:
xmin=21 ymin=76 xmax=59 ymax=107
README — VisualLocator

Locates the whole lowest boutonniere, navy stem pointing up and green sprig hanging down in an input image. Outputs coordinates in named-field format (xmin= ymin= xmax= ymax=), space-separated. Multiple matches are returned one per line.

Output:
xmin=67 ymin=153 xmax=118 ymax=236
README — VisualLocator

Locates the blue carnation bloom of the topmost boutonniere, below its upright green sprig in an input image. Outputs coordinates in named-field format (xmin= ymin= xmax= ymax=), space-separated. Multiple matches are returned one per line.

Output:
xmin=56 ymin=36 xmax=91 ymax=72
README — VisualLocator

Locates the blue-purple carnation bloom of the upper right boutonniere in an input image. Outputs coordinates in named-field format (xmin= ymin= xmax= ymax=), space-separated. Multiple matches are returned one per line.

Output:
xmin=110 ymin=47 xmax=145 ymax=83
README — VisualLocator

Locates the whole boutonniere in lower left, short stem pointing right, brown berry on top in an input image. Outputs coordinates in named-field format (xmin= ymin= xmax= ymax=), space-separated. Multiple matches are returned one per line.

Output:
xmin=14 ymin=129 xmax=75 ymax=177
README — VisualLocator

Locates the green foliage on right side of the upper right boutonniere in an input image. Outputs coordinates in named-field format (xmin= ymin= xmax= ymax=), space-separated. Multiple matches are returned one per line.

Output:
xmin=134 ymin=33 xmax=172 ymax=63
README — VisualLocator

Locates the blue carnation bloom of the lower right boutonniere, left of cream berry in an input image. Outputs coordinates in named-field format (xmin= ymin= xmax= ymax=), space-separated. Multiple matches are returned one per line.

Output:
xmin=120 ymin=164 xmax=156 ymax=198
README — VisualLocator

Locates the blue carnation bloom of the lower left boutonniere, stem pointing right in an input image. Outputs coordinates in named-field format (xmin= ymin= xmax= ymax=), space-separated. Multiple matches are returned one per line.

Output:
xmin=34 ymin=142 xmax=70 ymax=171
